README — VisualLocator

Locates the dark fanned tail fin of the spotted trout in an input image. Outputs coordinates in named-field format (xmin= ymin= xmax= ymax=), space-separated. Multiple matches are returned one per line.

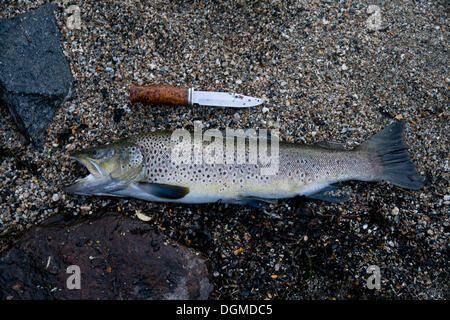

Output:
xmin=358 ymin=121 xmax=424 ymax=190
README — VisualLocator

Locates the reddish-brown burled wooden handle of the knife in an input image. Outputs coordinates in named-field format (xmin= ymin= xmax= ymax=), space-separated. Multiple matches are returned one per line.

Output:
xmin=130 ymin=85 xmax=189 ymax=106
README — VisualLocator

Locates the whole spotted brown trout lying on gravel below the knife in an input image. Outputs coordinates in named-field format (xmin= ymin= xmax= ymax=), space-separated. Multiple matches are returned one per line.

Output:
xmin=66 ymin=122 xmax=423 ymax=205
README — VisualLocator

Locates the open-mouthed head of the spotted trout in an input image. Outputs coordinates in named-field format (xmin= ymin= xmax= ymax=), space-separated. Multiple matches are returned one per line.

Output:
xmin=65 ymin=143 xmax=143 ymax=195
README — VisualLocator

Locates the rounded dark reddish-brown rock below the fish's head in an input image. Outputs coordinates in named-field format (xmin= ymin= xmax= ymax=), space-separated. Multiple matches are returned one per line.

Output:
xmin=0 ymin=213 xmax=212 ymax=300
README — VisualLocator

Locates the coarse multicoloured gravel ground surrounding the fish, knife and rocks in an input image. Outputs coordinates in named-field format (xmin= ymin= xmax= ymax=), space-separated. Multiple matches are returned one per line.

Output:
xmin=0 ymin=0 xmax=450 ymax=299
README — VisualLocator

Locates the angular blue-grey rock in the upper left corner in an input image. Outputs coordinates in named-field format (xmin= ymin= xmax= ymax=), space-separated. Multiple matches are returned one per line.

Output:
xmin=0 ymin=4 xmax=74 ymax=146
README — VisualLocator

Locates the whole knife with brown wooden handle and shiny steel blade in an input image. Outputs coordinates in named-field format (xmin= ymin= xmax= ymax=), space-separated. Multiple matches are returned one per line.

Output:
xmin=130 ymin=85 xmax=264 ymax=108
